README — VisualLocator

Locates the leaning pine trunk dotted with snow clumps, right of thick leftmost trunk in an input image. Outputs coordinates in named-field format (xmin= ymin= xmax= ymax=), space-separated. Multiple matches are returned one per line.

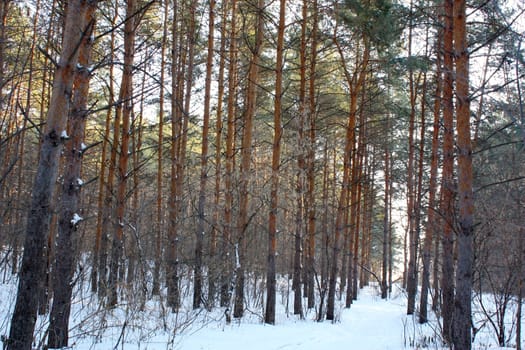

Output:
xmin=47 ymin=2 xmax=96 ymax=349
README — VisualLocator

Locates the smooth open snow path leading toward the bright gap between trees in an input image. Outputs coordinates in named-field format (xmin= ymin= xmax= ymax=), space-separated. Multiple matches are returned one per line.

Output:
xmin=177 ymin=289 xmax=406 ymax=350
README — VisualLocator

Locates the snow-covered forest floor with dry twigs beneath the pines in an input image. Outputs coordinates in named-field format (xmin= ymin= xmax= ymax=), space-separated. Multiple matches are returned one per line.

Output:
xmin=0 ymin=279 xmax=510 ymax=350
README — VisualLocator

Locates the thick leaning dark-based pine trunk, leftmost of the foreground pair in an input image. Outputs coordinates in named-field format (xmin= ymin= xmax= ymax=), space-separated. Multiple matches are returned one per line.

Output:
xmin=7 ymin=0 xmax=87 ymax=350
